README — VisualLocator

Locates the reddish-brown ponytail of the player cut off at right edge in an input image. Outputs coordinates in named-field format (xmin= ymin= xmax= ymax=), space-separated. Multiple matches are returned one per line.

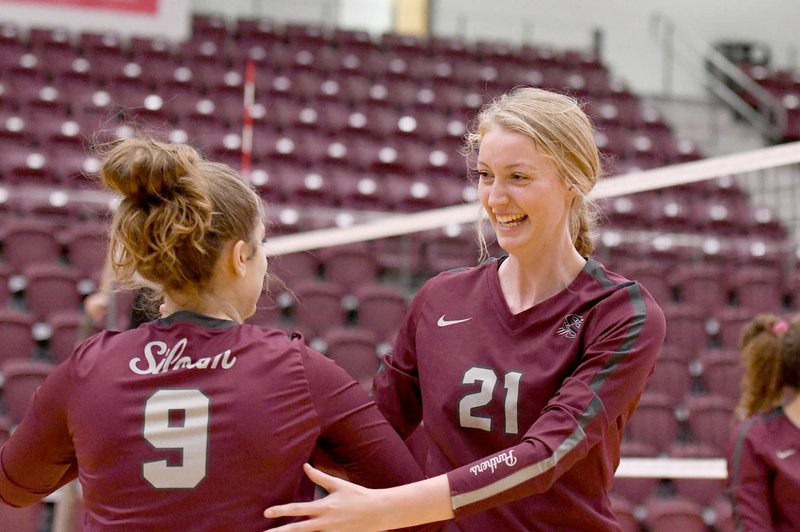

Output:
xmin=737 ymin=314 xmax=800 ymax=417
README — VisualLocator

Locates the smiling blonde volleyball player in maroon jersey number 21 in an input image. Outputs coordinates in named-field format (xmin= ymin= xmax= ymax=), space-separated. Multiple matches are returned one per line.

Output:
xmin=266 ymin=88 xmax=665 ymax=531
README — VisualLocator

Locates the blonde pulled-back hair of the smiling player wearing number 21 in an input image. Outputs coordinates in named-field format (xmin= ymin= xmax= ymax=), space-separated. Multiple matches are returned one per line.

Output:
xmin=463 ymin=87 xmax=602 ymax=256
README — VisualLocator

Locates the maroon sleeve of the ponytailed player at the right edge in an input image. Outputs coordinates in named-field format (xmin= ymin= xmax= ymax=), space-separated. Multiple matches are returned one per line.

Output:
xmin=728 ymin=419 xmax=773 ymax=531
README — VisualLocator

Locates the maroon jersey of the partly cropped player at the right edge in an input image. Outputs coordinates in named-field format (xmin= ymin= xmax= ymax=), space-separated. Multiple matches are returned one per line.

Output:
xmin=728 ymin=408 xmax=800 ymax=532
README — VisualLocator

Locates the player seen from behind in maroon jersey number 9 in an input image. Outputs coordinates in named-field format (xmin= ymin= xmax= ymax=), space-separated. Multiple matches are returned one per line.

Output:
xmin=0 ymin=138 xmax=423 ymax=531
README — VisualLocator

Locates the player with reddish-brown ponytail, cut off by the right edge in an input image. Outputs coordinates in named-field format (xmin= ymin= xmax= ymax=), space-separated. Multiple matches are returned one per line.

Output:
xmin=728 ymin=314 xmax=800 ymax=532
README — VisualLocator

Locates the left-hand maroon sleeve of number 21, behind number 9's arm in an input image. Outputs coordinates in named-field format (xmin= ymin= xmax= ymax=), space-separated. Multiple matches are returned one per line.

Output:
xmin=373 ymin=286 xmax=426 ymax=439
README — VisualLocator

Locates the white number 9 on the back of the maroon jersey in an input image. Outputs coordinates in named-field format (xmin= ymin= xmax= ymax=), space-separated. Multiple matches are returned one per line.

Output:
xmin=142 ymin=389 xmax=210 ymax=488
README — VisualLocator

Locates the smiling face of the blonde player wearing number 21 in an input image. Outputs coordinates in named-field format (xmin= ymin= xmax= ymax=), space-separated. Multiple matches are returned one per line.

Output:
xmin=477 ymin=125 xmax=575 ymax=255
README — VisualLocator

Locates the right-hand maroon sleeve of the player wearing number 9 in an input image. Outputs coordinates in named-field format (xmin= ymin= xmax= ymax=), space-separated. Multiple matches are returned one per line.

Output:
xmin=300 ymin=338 xmax=425 ymax=488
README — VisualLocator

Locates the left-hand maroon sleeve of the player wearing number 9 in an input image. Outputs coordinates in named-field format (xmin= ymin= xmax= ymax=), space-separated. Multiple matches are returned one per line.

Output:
xmin=0 ymin=362 xmax=78 ymax=507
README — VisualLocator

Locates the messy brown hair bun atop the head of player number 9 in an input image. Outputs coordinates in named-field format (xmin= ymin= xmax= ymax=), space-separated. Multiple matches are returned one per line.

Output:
xmin=101 ymin=138 xmax=200 ymax=203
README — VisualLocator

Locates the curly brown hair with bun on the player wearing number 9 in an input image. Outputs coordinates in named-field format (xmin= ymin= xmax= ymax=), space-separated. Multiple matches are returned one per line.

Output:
xmin=100 ymin=138 xmax=264 ymax=296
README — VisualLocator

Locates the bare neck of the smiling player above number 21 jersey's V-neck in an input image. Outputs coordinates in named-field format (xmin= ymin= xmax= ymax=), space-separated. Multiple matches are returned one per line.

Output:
xmin=499 ymin=245 xmax=586 ymax=314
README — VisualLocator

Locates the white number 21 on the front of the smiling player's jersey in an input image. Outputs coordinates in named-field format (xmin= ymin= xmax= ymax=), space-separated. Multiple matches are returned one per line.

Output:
xmin=458 ymin=368 xmax=522 ymax=434
